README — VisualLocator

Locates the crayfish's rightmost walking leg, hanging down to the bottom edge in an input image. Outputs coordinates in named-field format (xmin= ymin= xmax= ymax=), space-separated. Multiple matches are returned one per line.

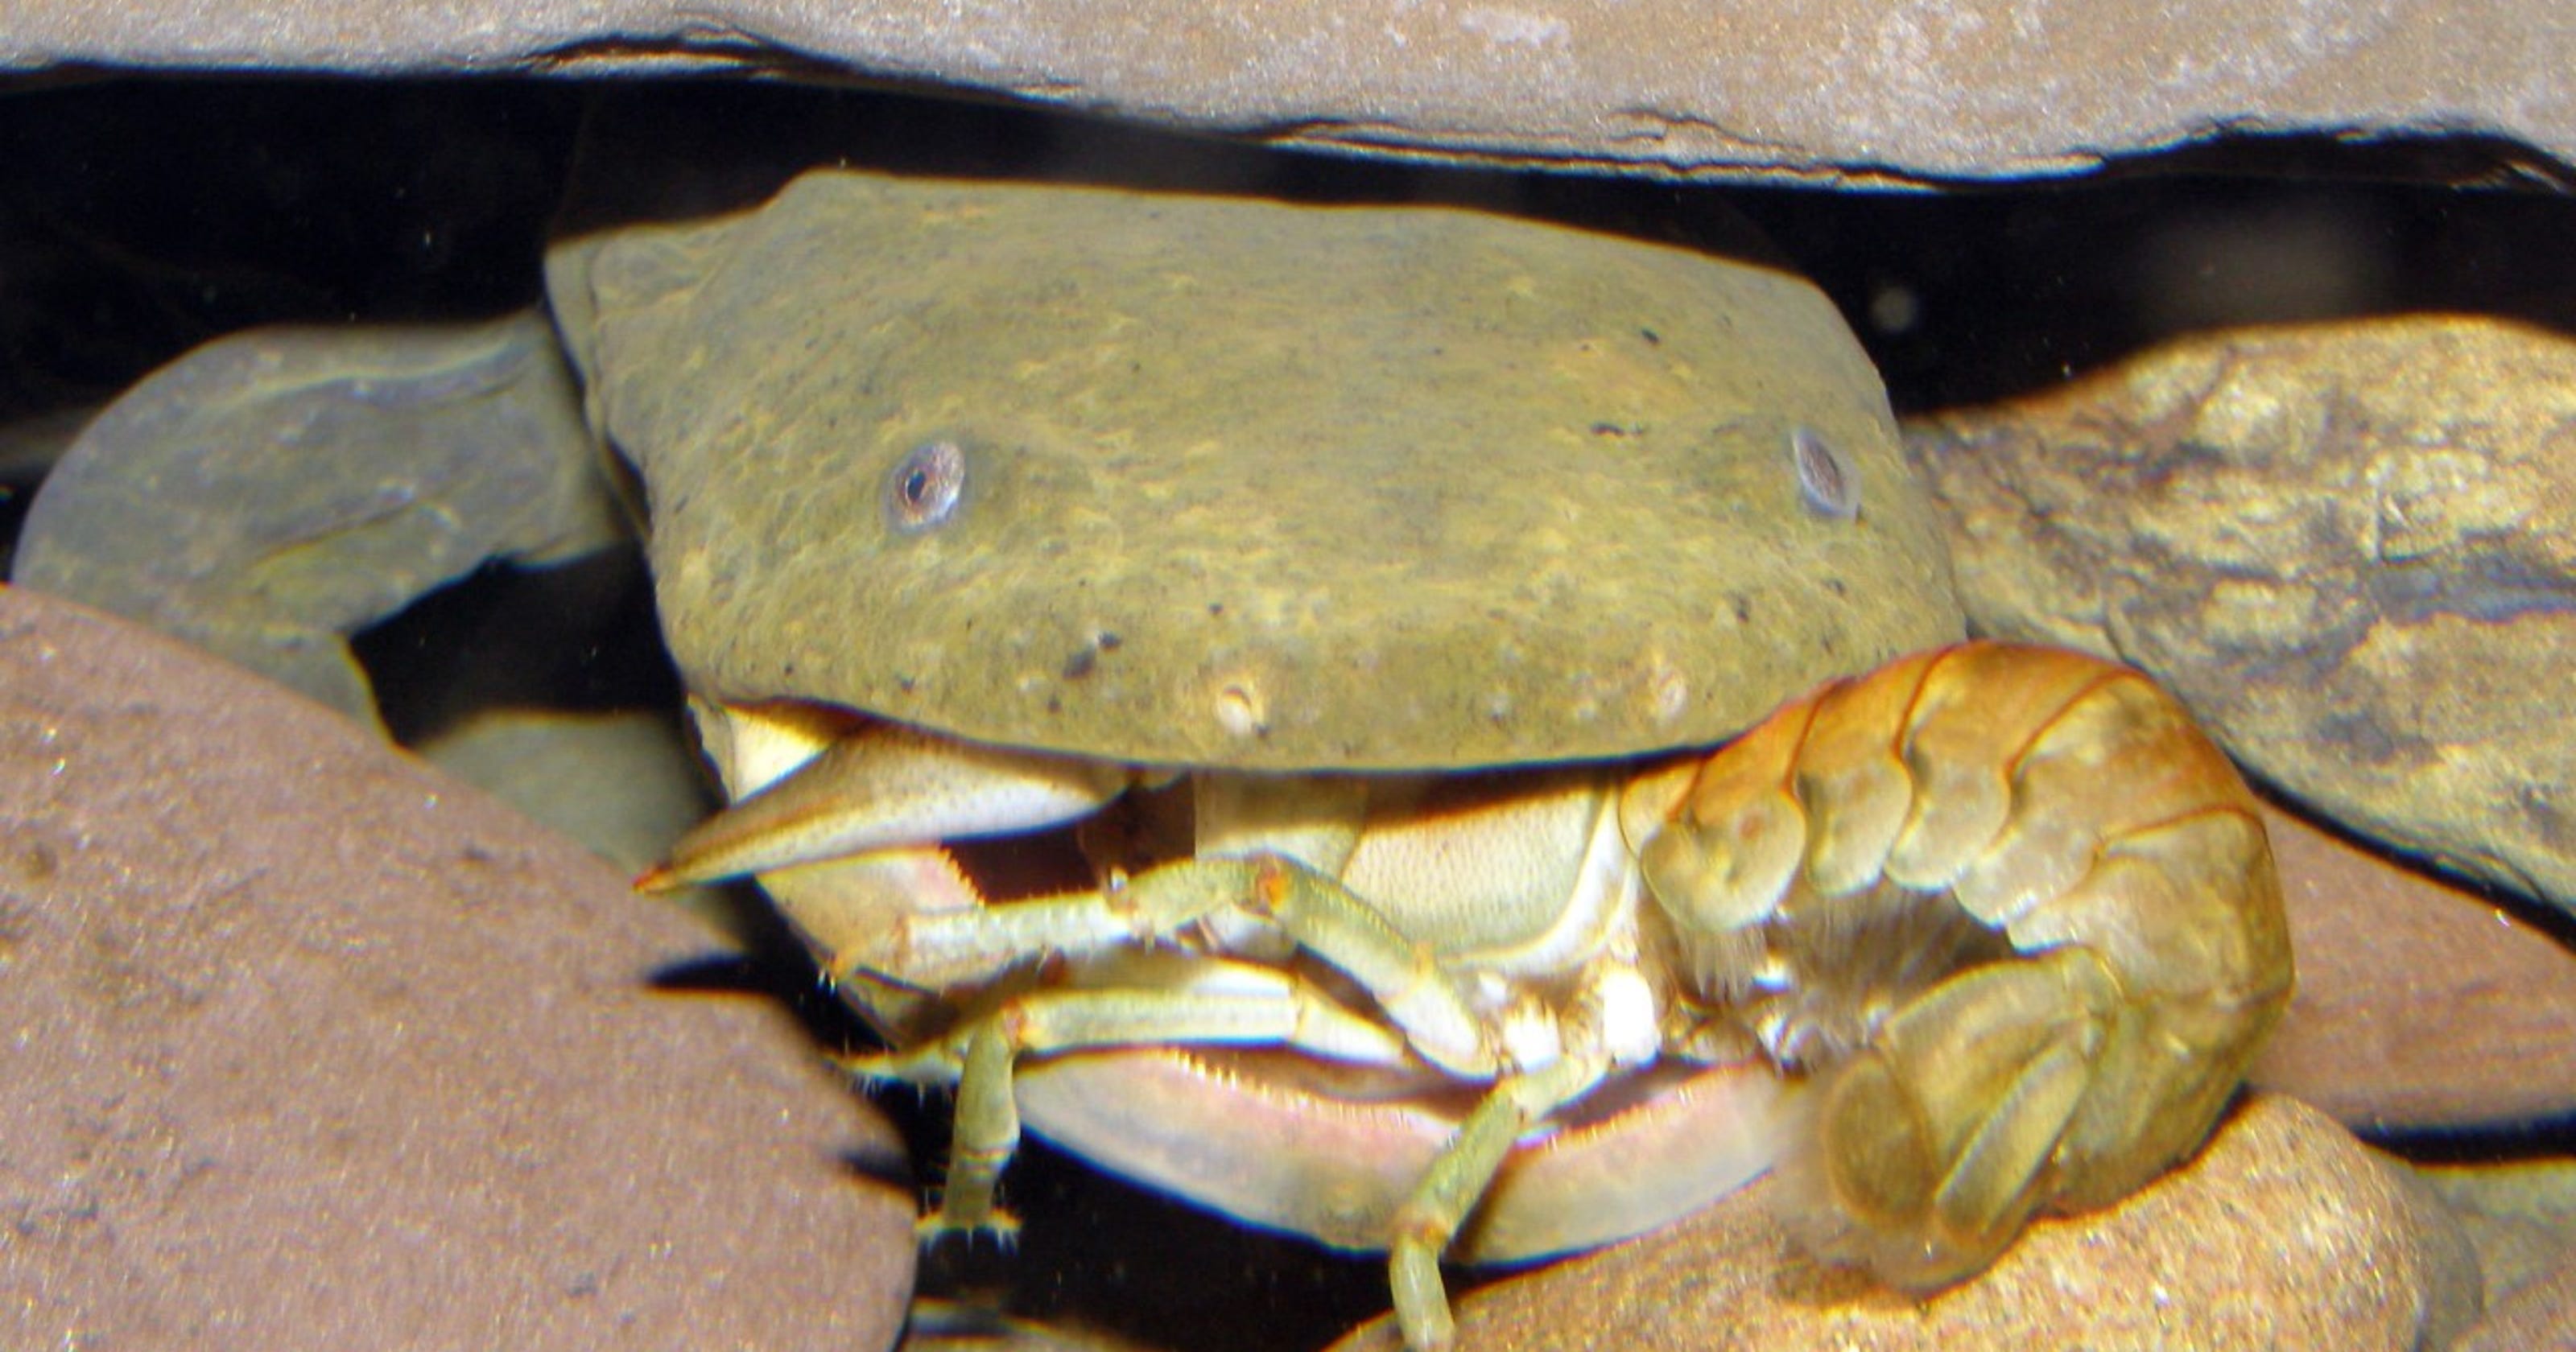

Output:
xmin=1386 ymin=1056 xmax=1610 ymax=1352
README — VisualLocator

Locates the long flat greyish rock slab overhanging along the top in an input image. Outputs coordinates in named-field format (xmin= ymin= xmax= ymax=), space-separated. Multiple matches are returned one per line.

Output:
xmin=0 ymin=0 xmax=2576 ymax=183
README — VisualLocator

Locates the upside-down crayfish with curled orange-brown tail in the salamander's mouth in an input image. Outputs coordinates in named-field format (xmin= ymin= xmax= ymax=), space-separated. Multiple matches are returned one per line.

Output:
xmin=646 ymin=644 xmax=2293 ymax=1350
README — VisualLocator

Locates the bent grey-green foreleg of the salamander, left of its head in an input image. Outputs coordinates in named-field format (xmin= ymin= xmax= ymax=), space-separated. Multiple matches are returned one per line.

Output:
xmin=10 ymin=314 xmax=621 ymax=723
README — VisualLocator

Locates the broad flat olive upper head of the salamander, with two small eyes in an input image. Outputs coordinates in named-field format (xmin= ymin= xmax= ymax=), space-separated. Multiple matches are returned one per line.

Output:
xmin=551 ymin=172 xmax=1960 ymax=770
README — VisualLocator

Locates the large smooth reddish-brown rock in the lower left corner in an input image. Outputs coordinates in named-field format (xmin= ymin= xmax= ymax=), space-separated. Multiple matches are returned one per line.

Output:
xmin=0 ymin=587 xmax=912 ymax=1350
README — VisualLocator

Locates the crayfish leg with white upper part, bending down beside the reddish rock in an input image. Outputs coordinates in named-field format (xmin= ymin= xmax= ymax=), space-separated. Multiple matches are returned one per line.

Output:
xmin=845 ymin=958 xmax=1404 ymax=1236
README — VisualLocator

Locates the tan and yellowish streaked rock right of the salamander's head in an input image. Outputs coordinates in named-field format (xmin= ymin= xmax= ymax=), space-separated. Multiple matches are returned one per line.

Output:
xmin=1909 ymin=317 xmax=2576 ymax=909
